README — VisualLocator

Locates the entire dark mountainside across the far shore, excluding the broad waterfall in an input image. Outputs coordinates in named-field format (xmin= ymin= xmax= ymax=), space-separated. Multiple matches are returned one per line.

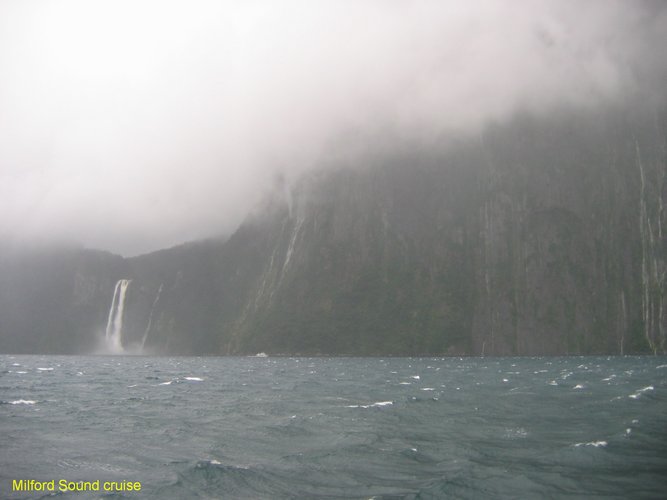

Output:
xmin=0 ymin=103 xmax=667 ymax=355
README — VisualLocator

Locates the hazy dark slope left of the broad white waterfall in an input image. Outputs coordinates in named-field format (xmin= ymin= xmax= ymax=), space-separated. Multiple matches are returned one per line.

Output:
xmin=0 ymin=246 xmax=126 ymax=354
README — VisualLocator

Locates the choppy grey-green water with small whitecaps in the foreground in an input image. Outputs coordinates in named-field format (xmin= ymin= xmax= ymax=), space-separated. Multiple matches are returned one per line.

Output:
xmin=0 ymin=355 xmax=667 ymax=499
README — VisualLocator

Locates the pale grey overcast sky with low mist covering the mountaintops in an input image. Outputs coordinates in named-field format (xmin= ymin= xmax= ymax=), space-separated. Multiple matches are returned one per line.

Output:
xmin=0 ymin=0 xmax=667 ymax=255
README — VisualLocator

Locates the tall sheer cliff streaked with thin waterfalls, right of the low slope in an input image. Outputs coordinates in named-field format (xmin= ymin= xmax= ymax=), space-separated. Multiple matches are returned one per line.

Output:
xmin=206 ymin=104 xmax=667 ymax=355
